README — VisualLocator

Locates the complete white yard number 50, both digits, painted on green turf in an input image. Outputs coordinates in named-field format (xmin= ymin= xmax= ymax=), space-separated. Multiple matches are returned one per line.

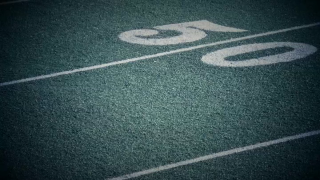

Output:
xmin=119 ymin=20 xmax=317 ymax=67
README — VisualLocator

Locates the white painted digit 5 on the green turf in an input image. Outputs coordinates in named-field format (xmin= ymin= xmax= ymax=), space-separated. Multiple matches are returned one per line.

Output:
xmin=119 ymin=20 xmax=246 ymax=45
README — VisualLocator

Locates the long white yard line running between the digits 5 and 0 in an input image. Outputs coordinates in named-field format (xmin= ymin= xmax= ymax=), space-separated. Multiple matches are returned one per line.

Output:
xmin=0 ymin=22 xmax=320 ymax=87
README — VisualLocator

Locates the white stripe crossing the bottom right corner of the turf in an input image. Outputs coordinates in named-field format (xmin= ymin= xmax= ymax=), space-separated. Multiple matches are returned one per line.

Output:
xmin=107 ymin=130 xmax=320 ymax=180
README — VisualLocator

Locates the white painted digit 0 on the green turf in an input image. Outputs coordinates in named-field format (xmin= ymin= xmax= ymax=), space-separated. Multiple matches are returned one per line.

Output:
xmin=201 ymin=42 xmax=317 ymax=67
